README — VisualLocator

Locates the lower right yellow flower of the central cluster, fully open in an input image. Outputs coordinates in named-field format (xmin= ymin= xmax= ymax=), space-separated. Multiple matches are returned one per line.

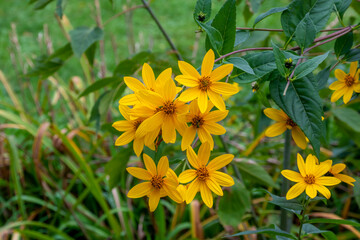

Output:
xmin=179 ymin=142 xmax=234 ymax=208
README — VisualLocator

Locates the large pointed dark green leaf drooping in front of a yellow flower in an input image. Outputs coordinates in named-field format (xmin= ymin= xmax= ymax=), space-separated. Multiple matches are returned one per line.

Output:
xmin=269 ymin=74 xmax=323 ymax=156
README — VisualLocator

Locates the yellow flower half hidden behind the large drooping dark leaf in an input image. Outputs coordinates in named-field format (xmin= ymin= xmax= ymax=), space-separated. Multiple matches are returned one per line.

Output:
xmin=264 ymin=108 xmax=307 ymax=149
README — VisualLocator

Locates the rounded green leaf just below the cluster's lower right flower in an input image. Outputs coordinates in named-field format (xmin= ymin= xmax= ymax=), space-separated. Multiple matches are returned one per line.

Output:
xmin=218 ymin=180 xmax=251 ymax=227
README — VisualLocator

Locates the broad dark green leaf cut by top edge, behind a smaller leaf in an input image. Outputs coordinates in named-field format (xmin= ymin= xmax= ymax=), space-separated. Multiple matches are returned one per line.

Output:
xmin=281 ymin=0 xmax=334 ymax=38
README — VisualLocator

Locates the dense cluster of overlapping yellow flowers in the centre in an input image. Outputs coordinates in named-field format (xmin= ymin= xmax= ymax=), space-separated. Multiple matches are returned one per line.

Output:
xmin=113 ymin=50 xmax=239 ymax=211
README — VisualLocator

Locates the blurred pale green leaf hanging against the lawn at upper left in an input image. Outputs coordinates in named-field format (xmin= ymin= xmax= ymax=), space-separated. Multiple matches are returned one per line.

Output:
xmin=70 ymin=27 xmax=104 ymax=57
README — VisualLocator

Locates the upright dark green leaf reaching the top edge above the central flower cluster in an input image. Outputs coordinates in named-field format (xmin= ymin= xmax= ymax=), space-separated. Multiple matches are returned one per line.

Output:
xmin=211 ymin=0 xmax=236 ymax=55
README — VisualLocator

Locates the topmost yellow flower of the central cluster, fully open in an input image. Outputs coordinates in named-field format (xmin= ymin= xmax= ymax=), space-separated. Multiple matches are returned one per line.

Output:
xmin=175 ymin=49 xmax=239 ymax=113
